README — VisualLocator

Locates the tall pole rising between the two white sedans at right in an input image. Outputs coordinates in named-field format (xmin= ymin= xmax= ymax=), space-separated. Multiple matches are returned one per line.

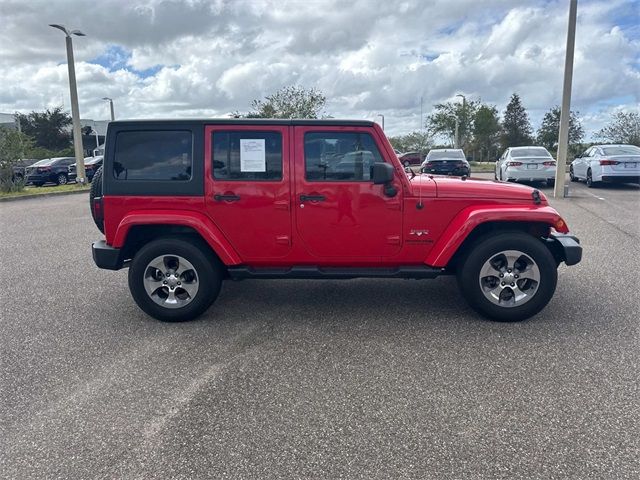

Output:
xmin=553 ymin=0 xmax=578 ymax=198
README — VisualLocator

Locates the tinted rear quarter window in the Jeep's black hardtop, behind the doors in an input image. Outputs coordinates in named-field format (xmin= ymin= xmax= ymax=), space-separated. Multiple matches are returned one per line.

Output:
xmin=113 ymin=130 xmax=193 ymax=181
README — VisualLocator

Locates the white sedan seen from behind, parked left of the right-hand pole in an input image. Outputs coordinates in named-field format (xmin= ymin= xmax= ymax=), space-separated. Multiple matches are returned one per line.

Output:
xmin=495 ymin=146 xmax=556 ymax=184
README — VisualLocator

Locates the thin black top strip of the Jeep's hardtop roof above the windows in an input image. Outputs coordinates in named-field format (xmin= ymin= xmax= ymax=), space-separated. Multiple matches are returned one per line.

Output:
xmin=109 ymin=118 xmax=375 ymax=127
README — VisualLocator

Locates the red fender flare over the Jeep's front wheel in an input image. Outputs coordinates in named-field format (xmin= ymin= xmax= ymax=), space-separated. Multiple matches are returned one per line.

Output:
xmin=424 ymin=205 xmax=569 ymax=268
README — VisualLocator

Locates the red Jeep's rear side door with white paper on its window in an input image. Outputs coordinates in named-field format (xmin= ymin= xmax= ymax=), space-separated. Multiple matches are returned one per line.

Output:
xmin=205 ymin=125 xmax=291 ymax=261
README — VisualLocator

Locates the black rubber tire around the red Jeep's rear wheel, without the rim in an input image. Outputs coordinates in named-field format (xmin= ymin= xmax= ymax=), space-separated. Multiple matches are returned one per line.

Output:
xmin=129 ymin=238 xmax=223 ymax=322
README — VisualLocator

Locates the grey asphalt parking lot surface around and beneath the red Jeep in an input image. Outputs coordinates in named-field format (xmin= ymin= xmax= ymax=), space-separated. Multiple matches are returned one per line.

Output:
xmin=0 ymin=175 xmax=640 ymax=479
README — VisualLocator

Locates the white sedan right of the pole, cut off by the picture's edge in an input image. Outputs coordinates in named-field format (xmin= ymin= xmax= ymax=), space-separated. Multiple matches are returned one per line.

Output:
xmin=569 ymin=145 xmax=640 ymax=187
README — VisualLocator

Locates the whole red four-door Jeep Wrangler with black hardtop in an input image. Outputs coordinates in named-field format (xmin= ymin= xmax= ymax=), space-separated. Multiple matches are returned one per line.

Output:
xmin=91 ymin=119 xmax=582 ymax=321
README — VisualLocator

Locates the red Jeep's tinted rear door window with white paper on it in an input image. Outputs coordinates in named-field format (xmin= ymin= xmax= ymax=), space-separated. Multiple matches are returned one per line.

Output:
xmin=213 ymin=130 xmax=282 ymax=180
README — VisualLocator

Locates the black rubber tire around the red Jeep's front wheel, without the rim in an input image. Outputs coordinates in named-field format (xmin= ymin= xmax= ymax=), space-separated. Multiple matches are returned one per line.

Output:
xmin=457 ymin=232 xmax=558 ymax=322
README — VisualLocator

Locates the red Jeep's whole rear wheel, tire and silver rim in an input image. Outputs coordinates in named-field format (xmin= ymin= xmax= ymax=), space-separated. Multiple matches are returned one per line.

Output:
xmin=129 ymin=238 xmax=222 ymax=322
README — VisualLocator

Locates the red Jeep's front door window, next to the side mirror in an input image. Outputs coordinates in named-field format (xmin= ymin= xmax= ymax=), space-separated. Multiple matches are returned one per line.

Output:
xmin=304 ymin=132 xmax=384 ymax=182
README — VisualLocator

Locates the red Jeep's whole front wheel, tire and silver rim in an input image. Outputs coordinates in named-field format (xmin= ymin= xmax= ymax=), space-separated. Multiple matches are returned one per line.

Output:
xmin=457 ymin=232 xmax=558 ymax=322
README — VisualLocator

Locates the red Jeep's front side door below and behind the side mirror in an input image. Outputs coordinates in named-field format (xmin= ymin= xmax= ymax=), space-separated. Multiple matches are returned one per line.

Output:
xmin=293 ymin=126 xmax=402 ymax=256
